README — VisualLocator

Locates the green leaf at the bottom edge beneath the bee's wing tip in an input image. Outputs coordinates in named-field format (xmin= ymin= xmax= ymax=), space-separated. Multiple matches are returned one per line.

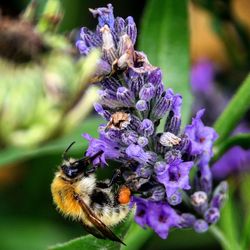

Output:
xmin=49 ymin=213 xmax=133 ymax=250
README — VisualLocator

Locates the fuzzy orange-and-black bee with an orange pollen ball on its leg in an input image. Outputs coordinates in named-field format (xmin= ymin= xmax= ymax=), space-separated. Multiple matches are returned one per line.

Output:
xmin=51 ymin=143 xmax=131 ymax=244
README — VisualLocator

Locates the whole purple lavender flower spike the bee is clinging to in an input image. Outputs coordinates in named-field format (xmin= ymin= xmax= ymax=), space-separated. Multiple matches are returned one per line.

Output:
xmin=76 ymin=4 xmax=227 ymax=238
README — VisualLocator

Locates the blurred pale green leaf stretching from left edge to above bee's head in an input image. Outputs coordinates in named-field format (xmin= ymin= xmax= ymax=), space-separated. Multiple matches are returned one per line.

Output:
xmin=0 ymin=118 xmax=101 ymax=168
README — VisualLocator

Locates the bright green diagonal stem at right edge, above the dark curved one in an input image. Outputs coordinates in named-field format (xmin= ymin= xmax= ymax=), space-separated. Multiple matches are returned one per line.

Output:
xmin=214 ymin=75 xmax=250 ymax=145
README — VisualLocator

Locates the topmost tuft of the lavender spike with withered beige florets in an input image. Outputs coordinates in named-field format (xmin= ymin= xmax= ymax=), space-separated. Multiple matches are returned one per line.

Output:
xmin=76 ymin=4 xmax=154 ymax=82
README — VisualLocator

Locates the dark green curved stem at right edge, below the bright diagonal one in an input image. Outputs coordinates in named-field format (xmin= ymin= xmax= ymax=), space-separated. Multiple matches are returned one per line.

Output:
xmin=213 ymin=134 xmax=250 ymax=162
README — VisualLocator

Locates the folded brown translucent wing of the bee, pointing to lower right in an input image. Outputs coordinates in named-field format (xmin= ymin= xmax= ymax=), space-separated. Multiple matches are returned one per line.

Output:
xmin=75 ymin=194 xmax=125 ymax=245
